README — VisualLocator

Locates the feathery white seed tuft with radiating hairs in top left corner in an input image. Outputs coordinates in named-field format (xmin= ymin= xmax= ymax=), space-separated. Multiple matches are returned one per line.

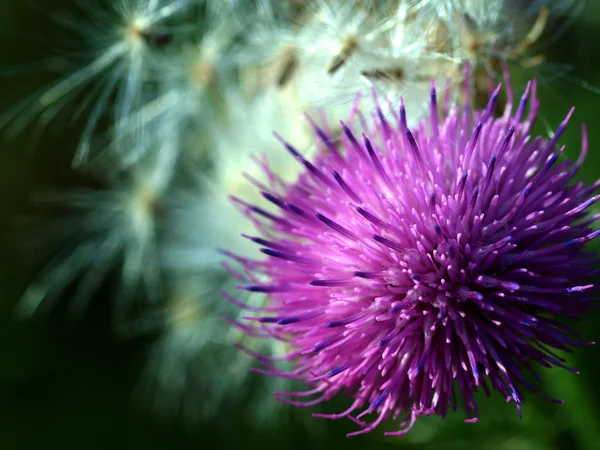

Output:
xmin=0 ymin=0 xmax=194 ymax=166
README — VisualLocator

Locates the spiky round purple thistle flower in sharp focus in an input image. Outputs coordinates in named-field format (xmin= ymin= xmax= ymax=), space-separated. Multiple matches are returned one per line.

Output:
xmin=227 ymin=74 xmax=600 ymax=436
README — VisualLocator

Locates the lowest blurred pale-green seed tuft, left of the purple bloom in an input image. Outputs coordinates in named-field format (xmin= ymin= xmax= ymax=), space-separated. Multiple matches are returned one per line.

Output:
xmin=132 ymin=273 xmax=232 ymax=421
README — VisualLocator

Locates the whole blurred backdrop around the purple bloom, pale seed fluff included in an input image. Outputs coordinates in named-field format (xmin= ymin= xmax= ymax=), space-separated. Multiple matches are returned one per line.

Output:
xmin=0 ymin=0 xmax=600 ymax=450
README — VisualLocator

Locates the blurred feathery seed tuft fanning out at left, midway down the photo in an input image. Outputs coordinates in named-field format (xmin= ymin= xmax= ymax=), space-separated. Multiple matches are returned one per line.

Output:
xmin=18 ymin=139 xmax=177 ymax=323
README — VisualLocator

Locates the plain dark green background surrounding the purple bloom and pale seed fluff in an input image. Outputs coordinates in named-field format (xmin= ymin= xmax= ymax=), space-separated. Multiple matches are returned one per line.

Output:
xmin=0 ymin=0 xmax=600 ymax=450
